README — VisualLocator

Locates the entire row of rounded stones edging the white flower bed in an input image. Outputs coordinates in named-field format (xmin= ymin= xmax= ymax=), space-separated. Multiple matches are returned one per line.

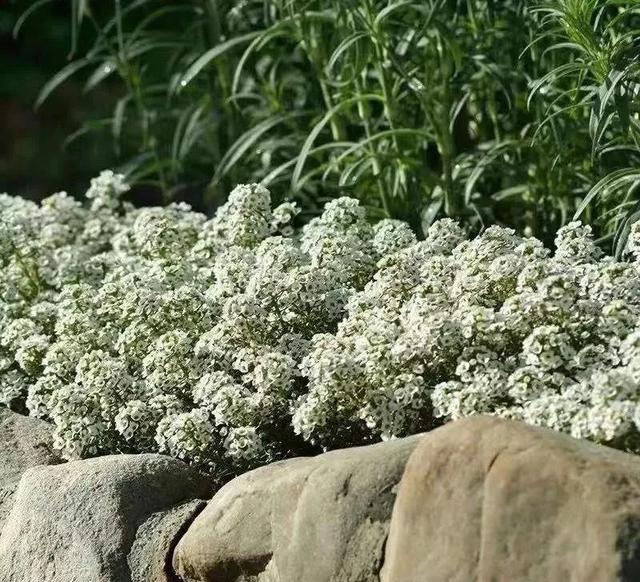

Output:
xmin=0 ymin=411 xmax=640 ymax=582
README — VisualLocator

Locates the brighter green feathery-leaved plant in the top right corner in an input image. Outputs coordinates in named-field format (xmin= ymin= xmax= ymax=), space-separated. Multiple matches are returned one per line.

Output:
xmin=530 ymin=0 xmax=640 ymax=248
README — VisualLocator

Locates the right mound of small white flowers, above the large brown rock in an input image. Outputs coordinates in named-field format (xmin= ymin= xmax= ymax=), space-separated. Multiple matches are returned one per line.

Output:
xmin=302 ymin=220 xmax=640 ymax=449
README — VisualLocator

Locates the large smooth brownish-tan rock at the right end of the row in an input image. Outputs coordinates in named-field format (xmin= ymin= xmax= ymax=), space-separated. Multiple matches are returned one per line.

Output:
xmin=381 ymin=417 xmax=640 ymax=582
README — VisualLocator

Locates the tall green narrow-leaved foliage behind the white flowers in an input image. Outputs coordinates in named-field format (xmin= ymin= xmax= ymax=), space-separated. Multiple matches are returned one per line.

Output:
xmin=16 ymin=0 xmax=640 ymax=244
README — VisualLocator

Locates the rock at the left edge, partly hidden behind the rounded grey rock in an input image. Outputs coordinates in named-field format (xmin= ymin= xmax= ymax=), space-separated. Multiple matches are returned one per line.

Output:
xmin=0 ymin=407 xmax=59 ymax=531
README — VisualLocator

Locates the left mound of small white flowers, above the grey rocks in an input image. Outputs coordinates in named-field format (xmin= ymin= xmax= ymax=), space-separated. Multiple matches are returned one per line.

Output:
xmin=0 ymin=172 xmax=415 ymax=467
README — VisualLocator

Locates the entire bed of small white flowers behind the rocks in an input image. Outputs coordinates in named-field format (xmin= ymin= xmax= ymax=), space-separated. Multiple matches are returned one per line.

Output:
xmin=0 ymin=172 xmax=640 ymax=472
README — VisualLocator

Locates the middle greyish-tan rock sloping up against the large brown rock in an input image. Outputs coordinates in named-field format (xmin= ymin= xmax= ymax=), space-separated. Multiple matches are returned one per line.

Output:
xmin=173 ymin=436 xmax=421 ymax=582
